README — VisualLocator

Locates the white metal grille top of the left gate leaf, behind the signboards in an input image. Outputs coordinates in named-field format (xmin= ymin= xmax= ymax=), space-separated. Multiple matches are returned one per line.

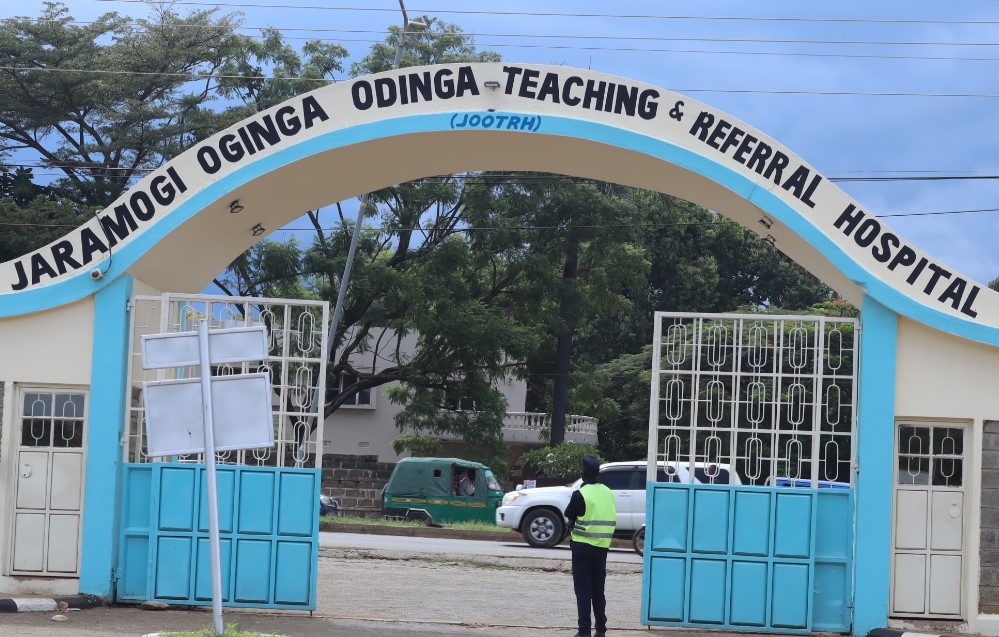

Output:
xmin=125 ymin=294 xmax=329 ymax=467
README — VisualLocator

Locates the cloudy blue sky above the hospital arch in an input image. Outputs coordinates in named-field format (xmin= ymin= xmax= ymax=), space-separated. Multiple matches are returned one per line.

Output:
xmin=7 ymin=0 xmax=999 ymax=283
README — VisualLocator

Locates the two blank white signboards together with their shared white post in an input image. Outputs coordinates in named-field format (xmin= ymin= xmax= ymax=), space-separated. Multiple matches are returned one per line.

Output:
xmin=142 ymin=319 xmax=274 ymax=635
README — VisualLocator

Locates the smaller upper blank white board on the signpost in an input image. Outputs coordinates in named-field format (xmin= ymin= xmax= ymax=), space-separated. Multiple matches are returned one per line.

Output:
xmin=142 ymin=325 xmax=268 ymax=369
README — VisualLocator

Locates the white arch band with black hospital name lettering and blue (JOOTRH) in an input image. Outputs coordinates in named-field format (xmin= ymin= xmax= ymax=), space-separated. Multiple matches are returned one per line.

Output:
xmin=0 ymin=64 xmax=981 ymax=319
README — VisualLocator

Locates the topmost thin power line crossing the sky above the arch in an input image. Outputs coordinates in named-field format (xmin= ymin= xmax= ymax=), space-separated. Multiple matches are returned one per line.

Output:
xmin=88 ymin=0 xmax=999 ymax=25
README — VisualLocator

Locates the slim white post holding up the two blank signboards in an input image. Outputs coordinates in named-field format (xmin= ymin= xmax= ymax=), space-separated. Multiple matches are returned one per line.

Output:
xmin=198 ymin=319 xmax=225 ymax=635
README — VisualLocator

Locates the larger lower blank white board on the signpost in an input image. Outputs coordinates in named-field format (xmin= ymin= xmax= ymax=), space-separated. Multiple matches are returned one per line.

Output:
xmin=143 ymin=373 xmax=274 ymax=457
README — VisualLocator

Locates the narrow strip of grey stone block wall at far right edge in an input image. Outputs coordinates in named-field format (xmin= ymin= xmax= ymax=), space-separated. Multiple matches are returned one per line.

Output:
xmin=980 ymin=420 xmax=999 ymax=614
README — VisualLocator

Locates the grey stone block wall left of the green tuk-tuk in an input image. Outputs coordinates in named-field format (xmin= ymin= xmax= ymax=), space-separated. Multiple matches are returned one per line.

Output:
xmin=322 ymin=454 xmax=395 ymax=518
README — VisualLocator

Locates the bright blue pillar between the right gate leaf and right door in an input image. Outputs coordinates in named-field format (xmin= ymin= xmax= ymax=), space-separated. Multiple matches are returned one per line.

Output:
xmin=853 ymin=296 xmax=898 ymax=635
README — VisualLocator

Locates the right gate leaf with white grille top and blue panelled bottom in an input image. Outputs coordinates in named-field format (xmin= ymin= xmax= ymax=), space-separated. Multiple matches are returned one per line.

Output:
xmin=642 ymin=313 xmax=858 ymax=634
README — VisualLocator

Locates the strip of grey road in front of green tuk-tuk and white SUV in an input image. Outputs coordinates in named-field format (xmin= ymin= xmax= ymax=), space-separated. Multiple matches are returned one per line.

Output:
xmin=319 ymin=533 xmax=642 ymax=564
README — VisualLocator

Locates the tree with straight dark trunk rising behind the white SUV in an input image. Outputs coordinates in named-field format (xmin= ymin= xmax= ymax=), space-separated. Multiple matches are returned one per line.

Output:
xmin=465 ymin=174 xmax=647 ymax=446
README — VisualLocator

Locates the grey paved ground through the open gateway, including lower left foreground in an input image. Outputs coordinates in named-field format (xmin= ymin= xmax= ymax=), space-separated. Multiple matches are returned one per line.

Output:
xmin=0 ymin=533 xmax=648 ymax=637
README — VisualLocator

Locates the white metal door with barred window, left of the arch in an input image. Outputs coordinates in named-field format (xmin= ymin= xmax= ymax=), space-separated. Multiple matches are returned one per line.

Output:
xmin=10 ymin=389 xmax=87 ymax=577
